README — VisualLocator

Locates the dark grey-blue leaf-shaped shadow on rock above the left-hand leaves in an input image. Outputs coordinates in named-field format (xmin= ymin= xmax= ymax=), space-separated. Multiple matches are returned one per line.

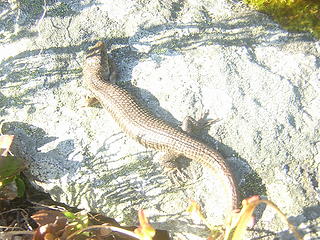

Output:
xmin=1 ymin=122 xmax=79 ymax=181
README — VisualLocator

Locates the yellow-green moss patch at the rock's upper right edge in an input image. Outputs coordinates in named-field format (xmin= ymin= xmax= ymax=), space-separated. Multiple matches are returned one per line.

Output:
xmin=244 ymin=0 xmax=320 ymax=38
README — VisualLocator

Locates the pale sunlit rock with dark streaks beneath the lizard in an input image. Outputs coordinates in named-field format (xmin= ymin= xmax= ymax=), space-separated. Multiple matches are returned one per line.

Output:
xmin=0 ymin=0 xmax=320 ymax=239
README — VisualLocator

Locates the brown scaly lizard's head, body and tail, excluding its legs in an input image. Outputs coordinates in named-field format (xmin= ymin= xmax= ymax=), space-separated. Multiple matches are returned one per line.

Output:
xmin=83 ymin=41 xmax=239 ymax=215
